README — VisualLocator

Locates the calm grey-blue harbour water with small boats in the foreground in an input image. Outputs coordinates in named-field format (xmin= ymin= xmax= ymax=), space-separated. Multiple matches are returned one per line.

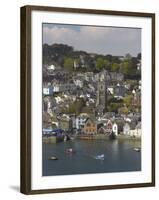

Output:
xmin=43 ymin=140 xmax=141 ymax=176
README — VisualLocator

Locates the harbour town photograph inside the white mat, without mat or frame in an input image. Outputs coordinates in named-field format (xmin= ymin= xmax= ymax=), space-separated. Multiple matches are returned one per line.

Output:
xmin=42 ymin=24 xmax=142 ymax=176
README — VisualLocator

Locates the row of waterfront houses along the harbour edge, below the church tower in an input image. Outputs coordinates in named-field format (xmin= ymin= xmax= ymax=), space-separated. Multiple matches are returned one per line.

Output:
xmin=46 ymin=113 xmax=141 ymax=137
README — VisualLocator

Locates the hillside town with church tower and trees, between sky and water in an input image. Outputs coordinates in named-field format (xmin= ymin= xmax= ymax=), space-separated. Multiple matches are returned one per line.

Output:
xmin=42 ymin=43 xmax=141 ymax=139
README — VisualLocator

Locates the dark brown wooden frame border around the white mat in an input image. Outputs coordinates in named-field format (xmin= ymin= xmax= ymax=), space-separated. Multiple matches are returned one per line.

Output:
xmin=20 ymin=5 xmax=155 ymax=194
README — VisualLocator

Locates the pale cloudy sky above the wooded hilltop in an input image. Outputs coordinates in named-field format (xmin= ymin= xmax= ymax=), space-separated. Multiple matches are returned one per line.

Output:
xmin=43 ymin=24 xmax=141 ymax=56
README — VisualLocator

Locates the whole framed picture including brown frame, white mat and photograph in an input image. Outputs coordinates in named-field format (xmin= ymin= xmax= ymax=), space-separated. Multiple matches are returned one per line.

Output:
xmin=21 ymin=6 xmax=155 ymax=194
